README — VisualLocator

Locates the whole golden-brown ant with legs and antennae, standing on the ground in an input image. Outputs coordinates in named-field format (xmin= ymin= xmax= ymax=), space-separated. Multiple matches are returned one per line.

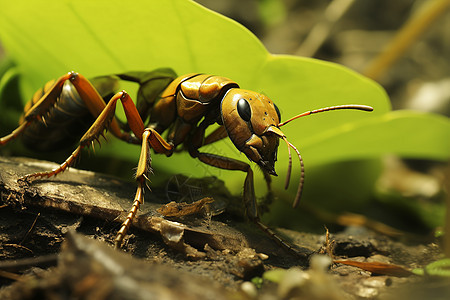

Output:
xmin=0 ymin=69 xmax=373 ymax=254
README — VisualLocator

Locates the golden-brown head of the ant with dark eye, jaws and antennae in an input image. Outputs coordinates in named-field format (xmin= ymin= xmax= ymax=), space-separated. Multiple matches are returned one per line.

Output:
xmin=221 ymin=88 xmax=373 ymax=207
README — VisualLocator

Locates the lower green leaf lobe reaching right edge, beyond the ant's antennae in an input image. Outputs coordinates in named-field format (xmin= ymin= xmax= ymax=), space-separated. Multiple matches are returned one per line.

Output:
xmin=304 ymin=111 xmax=450 ymax=163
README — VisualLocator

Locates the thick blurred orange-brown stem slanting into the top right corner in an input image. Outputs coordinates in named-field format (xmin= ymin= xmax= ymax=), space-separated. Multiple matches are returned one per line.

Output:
xmin=363 ymin=0 xmax=450 ymax=80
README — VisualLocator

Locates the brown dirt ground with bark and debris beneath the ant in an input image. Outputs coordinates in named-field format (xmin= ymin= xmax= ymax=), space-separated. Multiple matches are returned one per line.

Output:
xmin=0 ymin=157 xmax=450 ymax=299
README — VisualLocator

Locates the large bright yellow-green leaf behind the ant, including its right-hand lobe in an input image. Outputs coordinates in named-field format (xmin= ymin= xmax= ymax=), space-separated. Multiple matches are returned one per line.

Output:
xmin=0 ymin=0 xmax=450 ymax=202
